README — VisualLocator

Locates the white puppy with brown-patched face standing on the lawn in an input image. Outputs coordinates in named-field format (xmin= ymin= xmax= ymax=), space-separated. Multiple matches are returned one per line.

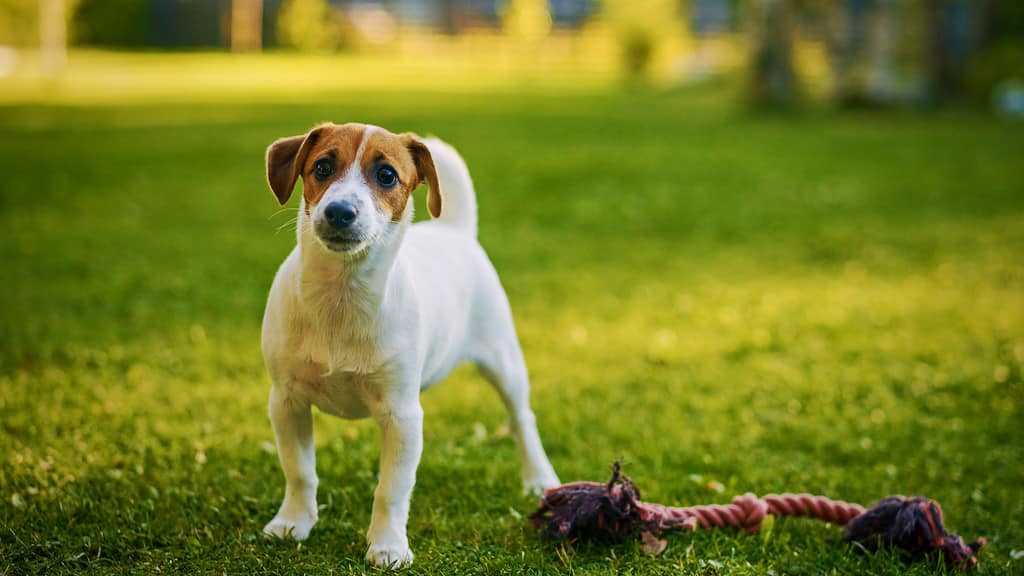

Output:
xmin=256 ymin=124 xmax=559 ymax=568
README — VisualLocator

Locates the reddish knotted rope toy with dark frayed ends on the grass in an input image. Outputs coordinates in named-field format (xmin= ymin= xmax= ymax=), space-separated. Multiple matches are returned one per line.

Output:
xmin=529 ymin=462 xmax=986 ymax=570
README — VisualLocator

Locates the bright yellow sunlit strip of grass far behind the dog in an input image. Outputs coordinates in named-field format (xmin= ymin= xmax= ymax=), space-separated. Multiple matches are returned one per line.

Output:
xmin=0 ymin=43 xmax=617 ymax=105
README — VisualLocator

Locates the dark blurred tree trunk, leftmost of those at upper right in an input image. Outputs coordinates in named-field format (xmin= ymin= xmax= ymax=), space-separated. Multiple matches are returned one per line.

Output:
xmin=751 ymin=0 xmax=797 ymax=106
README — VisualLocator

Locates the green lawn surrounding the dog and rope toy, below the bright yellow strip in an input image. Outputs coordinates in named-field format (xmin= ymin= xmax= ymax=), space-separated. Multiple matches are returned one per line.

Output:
xmin=0 ymin=55 xmax=1024 ymax=574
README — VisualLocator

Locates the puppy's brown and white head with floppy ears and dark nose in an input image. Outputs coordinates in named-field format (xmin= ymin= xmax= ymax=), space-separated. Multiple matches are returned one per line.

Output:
xmin=266 ymin=124 xmax=441 ymax=253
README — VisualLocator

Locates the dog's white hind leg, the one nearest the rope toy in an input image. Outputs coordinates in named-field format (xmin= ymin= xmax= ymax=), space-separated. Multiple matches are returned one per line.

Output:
xmin=476 ymin=340 xmax=560 ymax=493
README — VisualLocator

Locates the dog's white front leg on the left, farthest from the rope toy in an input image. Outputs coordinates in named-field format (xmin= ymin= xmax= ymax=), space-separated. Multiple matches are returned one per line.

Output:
xmin=263 ymin=385 xmax=317 ymax=540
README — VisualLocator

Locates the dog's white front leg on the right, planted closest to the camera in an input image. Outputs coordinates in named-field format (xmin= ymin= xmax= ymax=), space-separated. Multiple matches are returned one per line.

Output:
xmin=367 ymin=385 xmax=423 ymax=568
